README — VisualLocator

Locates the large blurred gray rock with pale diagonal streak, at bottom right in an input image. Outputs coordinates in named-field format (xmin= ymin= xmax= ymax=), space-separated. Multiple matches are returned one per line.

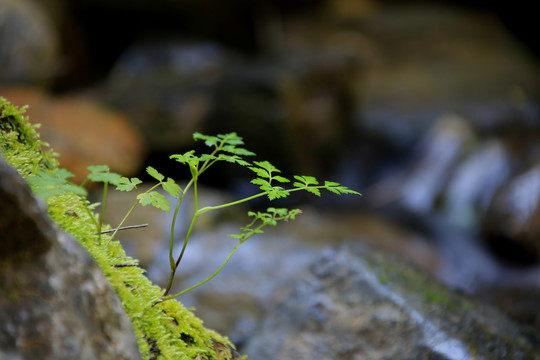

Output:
xmin=245 ymin=247 xmax=540 ymax=360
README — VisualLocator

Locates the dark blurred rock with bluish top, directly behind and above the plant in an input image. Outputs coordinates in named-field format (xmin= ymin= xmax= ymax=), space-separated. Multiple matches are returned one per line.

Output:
xmin=106 ymin=40 xmax=234 ymax=152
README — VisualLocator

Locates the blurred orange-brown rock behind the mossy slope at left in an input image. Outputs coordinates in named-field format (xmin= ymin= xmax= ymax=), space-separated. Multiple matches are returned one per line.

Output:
xmin=0 ymin=87 xmax=146 ymax=183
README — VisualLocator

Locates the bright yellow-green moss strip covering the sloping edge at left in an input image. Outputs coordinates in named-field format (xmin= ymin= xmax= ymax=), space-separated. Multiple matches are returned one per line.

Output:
xmin=0 ymin=97 xmax=238 ymax=360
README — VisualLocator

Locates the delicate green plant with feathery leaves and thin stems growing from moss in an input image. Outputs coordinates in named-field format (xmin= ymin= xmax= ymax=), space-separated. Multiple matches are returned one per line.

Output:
xmin=29 ymin=132 xmax=361 ymax=304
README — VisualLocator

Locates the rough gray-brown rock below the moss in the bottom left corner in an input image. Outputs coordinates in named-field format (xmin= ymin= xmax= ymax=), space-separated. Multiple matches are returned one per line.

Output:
xmin=0 ymin=159 xmax=141 ymax=360
